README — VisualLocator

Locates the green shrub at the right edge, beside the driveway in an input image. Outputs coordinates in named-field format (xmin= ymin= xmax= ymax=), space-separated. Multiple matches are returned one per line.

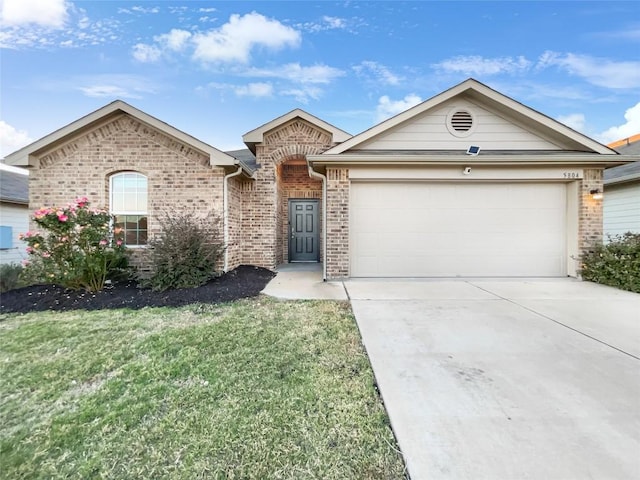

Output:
xmin=580 ymin=232 xmax=640 ymax=293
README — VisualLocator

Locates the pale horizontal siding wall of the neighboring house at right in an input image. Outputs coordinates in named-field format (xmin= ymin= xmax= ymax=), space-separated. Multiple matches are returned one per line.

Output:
xmin=603 ymin=182 xmax=640 ymax=238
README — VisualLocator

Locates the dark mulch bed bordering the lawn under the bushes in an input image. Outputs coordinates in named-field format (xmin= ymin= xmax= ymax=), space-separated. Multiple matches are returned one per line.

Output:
xmin=0 ymin=265 xmax=275 ymax=313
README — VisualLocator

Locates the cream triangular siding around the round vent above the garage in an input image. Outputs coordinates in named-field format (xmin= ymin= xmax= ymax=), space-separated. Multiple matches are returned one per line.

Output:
xmin=360 ymin=99 xmax=560 ymax=151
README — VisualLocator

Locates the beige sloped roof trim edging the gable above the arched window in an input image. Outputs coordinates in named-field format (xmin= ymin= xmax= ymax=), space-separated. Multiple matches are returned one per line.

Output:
xmin=4 ymin=100 xmax=253 ymax=175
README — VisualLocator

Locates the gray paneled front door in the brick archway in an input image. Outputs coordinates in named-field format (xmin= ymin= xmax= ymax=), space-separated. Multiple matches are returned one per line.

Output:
xmin=289 ymin=200 xmax=320 ymax=262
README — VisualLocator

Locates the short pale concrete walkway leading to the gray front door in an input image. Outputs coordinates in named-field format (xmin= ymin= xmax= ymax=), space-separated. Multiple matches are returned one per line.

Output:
xmin=262 ymin=263 xmax=347 ymax=300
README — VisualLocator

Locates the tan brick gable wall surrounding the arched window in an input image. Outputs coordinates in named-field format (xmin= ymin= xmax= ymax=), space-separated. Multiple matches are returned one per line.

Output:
xmin=29 ymin=114 xmax=224 ymax=275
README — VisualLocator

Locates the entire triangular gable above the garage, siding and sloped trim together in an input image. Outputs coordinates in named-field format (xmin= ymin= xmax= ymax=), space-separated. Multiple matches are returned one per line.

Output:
xmin=324 ymin=79 xmax=616 ymax=155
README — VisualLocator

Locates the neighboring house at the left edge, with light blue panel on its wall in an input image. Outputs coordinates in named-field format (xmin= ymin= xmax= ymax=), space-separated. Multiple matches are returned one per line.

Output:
xmin=0 ymin=168 xmax=29 ymax=264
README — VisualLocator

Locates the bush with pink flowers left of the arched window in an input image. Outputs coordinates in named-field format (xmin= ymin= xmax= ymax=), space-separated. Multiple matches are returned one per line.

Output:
xmin=20 ymin=197 xmax=128 ymax=292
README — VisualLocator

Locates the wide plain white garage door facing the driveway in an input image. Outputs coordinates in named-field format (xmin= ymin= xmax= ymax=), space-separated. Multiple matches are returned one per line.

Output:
xmin=350 ymin=182 xmax=566 ymax=277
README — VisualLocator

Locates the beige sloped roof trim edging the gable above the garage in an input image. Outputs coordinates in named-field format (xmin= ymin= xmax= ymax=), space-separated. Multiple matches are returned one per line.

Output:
xmin=324 ymin=78 xmax=616 ymax=155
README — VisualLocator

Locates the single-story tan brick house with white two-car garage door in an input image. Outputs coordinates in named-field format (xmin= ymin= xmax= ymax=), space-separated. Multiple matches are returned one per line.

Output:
xmin=6 ymin=79 xmax=624 ymax=279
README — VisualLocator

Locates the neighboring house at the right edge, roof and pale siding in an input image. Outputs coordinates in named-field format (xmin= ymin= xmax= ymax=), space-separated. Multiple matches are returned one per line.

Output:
xmin=604 ymin=134 xmax=640 ymax=240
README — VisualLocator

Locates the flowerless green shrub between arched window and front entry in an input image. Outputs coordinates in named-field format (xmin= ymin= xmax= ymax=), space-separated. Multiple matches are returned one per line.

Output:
xmin=147 ymin=208 xmax=225 ymax=290
